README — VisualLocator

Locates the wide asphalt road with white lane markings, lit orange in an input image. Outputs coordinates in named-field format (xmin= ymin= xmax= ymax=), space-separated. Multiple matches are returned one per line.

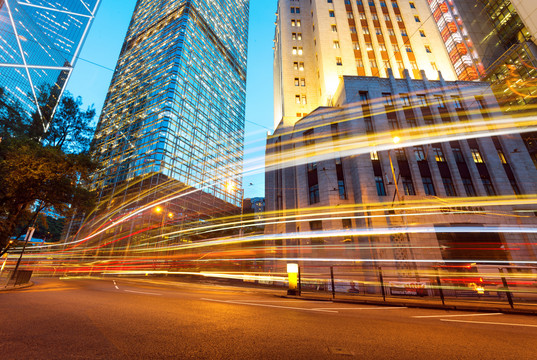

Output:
xmin=0 ymin=279 xmax=537 ymax=360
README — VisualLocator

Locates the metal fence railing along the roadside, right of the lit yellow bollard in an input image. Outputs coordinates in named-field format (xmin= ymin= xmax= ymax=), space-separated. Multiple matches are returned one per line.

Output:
xmin=282 ymin=264 xmax=537 ymax=310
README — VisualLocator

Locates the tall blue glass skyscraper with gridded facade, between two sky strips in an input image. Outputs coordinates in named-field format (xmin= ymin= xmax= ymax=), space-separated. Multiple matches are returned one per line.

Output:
xmin=84 ymin=0 xmax=249 ymax=245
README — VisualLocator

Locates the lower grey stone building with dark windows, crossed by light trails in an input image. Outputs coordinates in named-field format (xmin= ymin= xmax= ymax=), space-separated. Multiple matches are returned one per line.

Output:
xmin=265 ymin=74 xmax=537 ymax=266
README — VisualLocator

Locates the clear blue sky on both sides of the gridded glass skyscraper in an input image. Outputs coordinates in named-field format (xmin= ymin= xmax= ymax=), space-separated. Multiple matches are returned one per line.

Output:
xmin=67 ymin=0 xmax=277 ymax=198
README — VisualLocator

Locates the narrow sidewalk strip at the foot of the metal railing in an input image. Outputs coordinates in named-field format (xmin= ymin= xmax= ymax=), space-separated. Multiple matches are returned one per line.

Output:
xmin=281 ymin=291 xmax=537 ymax=315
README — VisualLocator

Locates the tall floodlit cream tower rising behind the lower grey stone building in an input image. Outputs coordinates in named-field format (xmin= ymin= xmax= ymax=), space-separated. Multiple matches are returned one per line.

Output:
xmin=274 ymin=0 xmax=457 ymax=128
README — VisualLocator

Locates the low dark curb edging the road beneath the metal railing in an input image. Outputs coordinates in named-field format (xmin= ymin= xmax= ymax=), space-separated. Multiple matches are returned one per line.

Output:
xmin=278 ymin=295 xmax=537 ymax=316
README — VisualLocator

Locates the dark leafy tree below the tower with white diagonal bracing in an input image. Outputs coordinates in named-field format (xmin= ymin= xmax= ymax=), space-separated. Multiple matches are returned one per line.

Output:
xmin=0 ymin=87 xmax=97 ymax=255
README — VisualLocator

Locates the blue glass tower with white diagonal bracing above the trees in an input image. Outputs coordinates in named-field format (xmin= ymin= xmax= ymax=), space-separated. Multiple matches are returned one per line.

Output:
xmin=0 ymin=0 xmax=100 ymax=121
